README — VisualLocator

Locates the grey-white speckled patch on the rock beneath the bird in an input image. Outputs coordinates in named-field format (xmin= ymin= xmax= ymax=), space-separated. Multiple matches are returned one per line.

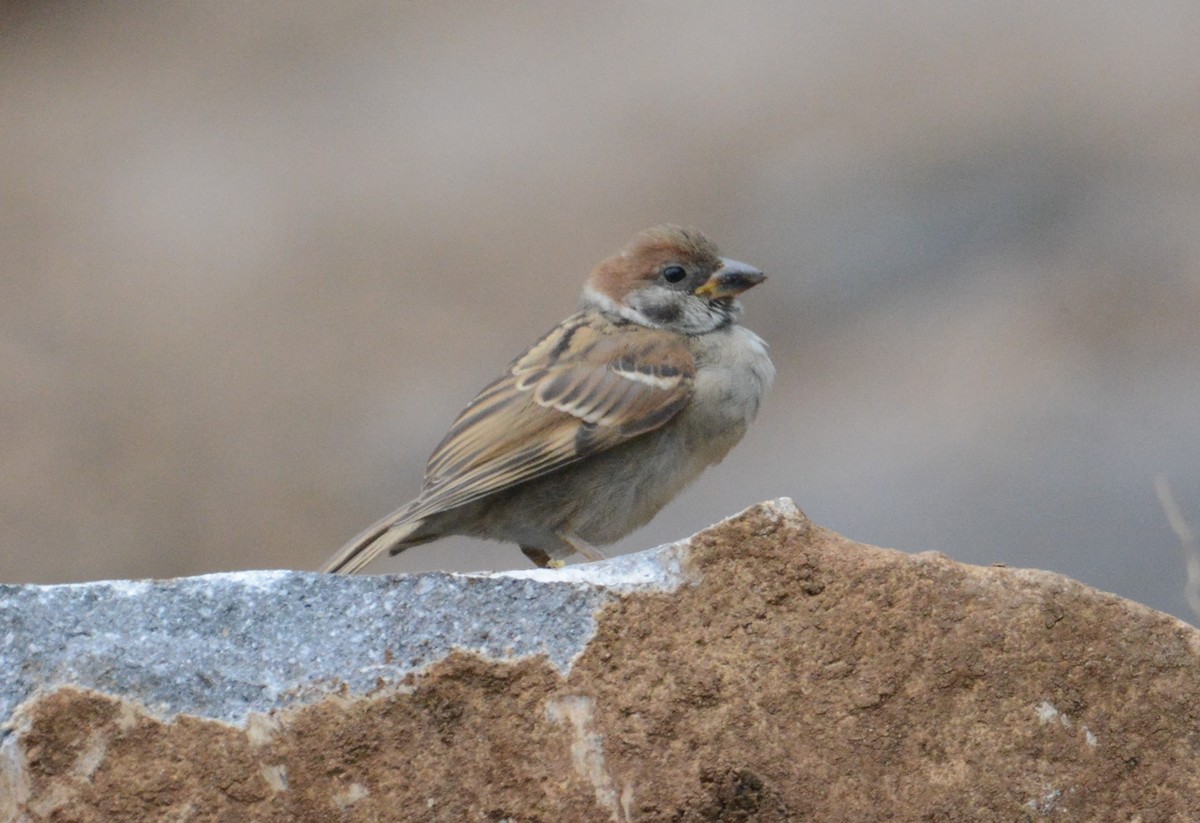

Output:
xmin=0 ymin=504 xmax=700 ymax=724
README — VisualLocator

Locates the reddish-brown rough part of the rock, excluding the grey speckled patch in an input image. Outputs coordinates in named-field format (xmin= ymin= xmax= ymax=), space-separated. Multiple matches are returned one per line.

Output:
xmin=0 ymin=505 xmax=1200 ymax=823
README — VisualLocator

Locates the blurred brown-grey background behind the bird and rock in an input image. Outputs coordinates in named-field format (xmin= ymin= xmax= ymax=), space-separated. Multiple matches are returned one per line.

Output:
xmin=0 ymin=0 xmax=1200 ymax=619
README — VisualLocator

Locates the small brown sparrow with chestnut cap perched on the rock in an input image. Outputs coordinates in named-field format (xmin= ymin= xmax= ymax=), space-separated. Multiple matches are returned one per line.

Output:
xmin=323 ymin=226 xmax=775 ymax=573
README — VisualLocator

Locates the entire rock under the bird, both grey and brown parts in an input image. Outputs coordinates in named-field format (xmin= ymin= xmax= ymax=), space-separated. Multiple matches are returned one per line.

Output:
xmin=0 ymin=500 xmax=1200 ymax=823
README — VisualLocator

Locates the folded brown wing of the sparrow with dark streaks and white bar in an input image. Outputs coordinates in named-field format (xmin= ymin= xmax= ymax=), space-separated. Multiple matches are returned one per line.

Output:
xmin=404 ymin=312 xmax=696 ymax=519
